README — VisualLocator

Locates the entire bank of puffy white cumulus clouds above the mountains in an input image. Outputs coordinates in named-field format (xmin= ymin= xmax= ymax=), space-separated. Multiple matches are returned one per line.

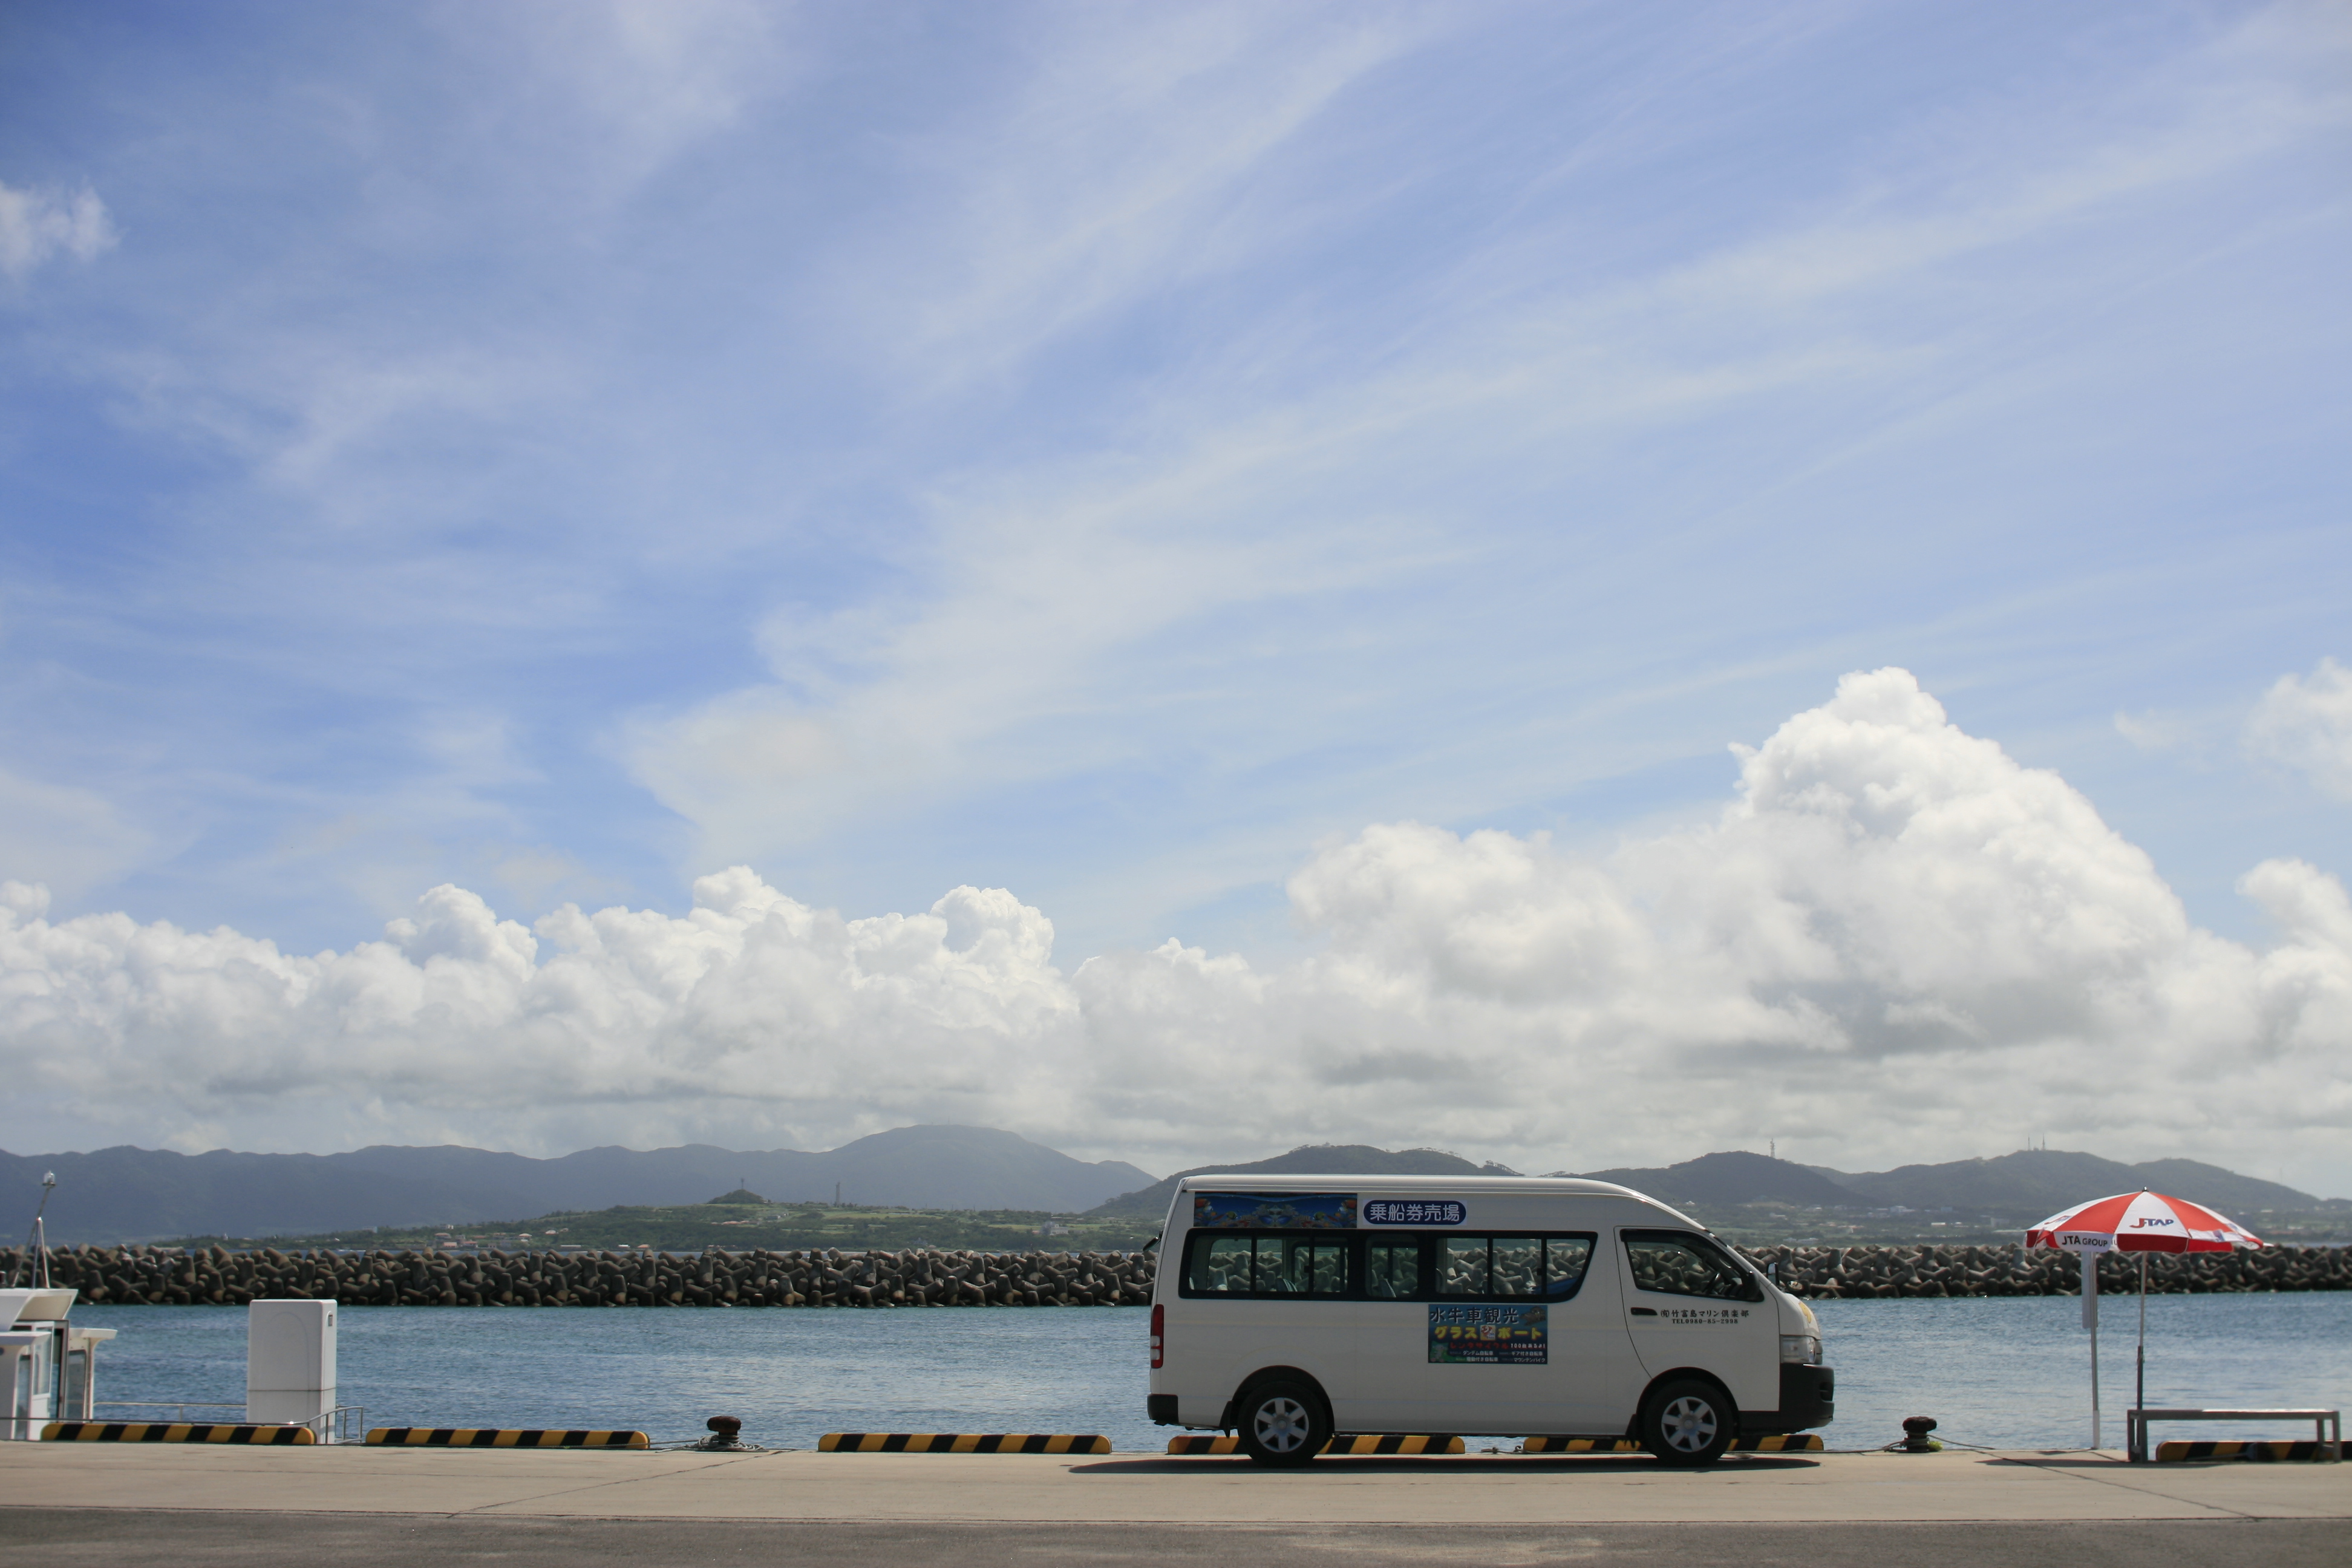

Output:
xmin=0 ymin=670 xmax=2352 ymax=1189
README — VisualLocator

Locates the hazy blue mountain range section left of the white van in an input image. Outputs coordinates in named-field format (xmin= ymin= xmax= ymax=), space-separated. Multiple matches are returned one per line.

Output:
xmin=0 ymin=1126 xmax=1152 ymax=1244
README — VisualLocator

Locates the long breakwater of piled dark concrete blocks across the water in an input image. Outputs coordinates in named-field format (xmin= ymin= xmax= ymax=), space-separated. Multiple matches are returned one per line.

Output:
xmin=0 ymin=1246 xmax=2352 ymax=1307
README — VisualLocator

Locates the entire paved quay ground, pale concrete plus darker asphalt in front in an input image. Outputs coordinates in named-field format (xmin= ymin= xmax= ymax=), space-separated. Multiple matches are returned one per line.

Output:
xmin=0 ymin=1443 xmax=2352 ymax=1568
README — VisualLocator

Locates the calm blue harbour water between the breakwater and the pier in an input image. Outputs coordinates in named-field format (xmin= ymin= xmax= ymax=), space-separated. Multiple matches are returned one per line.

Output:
xmin=73 ymin=1293 xmax=2352 ymax=1451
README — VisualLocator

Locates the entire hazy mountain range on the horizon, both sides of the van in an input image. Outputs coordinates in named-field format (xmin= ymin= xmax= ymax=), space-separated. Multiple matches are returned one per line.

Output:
xmin=0 ymin=1126 xmax=2352 ymax=1244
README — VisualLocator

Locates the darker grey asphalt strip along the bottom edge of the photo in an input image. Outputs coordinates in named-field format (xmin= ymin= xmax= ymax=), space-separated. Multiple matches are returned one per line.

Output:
xmin=0 ymin=1509 xmax=2352 ymax=1568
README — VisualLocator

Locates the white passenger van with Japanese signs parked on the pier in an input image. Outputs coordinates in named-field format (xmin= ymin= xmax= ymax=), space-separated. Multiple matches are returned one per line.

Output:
xmin=1150 ymin=1175 xmax=1835 ymax=1465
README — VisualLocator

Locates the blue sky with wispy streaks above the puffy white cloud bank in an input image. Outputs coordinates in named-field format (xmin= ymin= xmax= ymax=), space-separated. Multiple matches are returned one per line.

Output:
xmin=0 ymin=0 xmax=2352 ymax=1175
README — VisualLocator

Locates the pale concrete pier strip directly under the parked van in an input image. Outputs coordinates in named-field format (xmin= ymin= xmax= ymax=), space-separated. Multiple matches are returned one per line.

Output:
xmin=0 ymin=1443 xmax=2352 ymax=1544
